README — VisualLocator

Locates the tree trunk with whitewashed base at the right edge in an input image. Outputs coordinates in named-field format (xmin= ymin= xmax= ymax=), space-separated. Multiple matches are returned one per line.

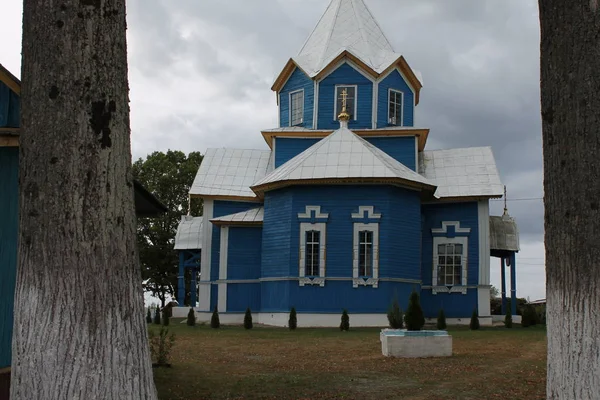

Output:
xmin=539 ymin=0 xmax=600 ymax=400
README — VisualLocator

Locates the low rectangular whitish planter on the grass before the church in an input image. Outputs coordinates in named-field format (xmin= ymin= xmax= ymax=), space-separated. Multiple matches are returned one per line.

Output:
xmin=379 ymin=329 xmax=452 ymax=358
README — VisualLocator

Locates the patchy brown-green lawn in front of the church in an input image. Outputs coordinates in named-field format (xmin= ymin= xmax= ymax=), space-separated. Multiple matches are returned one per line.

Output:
xmin=151 ymin=317 xmax=546 ymax=400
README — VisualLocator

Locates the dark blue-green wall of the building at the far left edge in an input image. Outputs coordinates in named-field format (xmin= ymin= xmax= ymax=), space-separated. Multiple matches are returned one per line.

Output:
xmin=0 ymin=147 xmax=19 ymax=369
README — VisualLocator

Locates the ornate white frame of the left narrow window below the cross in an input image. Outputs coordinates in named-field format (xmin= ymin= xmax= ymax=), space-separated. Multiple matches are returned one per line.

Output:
xmin=298 ymin=206 xmax=329 ymax=287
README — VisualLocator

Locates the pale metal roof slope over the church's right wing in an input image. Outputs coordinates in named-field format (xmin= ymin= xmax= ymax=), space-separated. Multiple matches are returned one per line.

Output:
xmin=419 ymin=147 xmax=504 ymax=198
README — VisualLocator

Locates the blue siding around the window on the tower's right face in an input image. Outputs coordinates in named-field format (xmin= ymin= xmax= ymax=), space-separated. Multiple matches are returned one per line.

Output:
xmin=377 ymin=70 xmax=414 ymax=128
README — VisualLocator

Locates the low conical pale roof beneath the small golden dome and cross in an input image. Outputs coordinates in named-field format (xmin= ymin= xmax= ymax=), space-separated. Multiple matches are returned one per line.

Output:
xmin=253 ymin=128 xmax=434 ymax=191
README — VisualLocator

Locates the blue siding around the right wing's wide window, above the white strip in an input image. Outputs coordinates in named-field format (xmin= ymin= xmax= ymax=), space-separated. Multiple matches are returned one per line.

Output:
xmin=421 ymin=202 xmax=479 ymax=288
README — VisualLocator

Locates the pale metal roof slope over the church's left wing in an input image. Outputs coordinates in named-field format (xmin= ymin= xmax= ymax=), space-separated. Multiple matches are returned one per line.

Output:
xmin=190 ymin=149 xmax=271 ymax=197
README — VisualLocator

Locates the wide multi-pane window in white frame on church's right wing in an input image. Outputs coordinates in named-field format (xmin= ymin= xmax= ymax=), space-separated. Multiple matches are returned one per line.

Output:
xmin=432 ymin=236 xmax=469 ymax=294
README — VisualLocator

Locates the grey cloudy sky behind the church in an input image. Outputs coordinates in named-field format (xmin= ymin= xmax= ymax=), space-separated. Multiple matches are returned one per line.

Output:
xmin=0 ymin=0 xmax=545 ymax=300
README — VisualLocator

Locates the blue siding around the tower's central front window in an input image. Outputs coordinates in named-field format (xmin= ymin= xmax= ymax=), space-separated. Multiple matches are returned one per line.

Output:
xmin=317 ymin=64 xmax=373 ymax=129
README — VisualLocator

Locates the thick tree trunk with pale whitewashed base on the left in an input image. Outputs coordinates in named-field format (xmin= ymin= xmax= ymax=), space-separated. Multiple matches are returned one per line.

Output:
xmin=11 ymin=0 xmax=156 ymax=400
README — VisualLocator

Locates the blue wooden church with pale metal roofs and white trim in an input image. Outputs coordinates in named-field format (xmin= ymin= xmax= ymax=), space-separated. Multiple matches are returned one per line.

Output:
xmin=176 ymin=0 xmax=514 ymax=326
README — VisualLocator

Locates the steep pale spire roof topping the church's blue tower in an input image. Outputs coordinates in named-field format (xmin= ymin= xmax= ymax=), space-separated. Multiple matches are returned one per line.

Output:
xmin=293 ymin=0 xmax=421 ymax=80
